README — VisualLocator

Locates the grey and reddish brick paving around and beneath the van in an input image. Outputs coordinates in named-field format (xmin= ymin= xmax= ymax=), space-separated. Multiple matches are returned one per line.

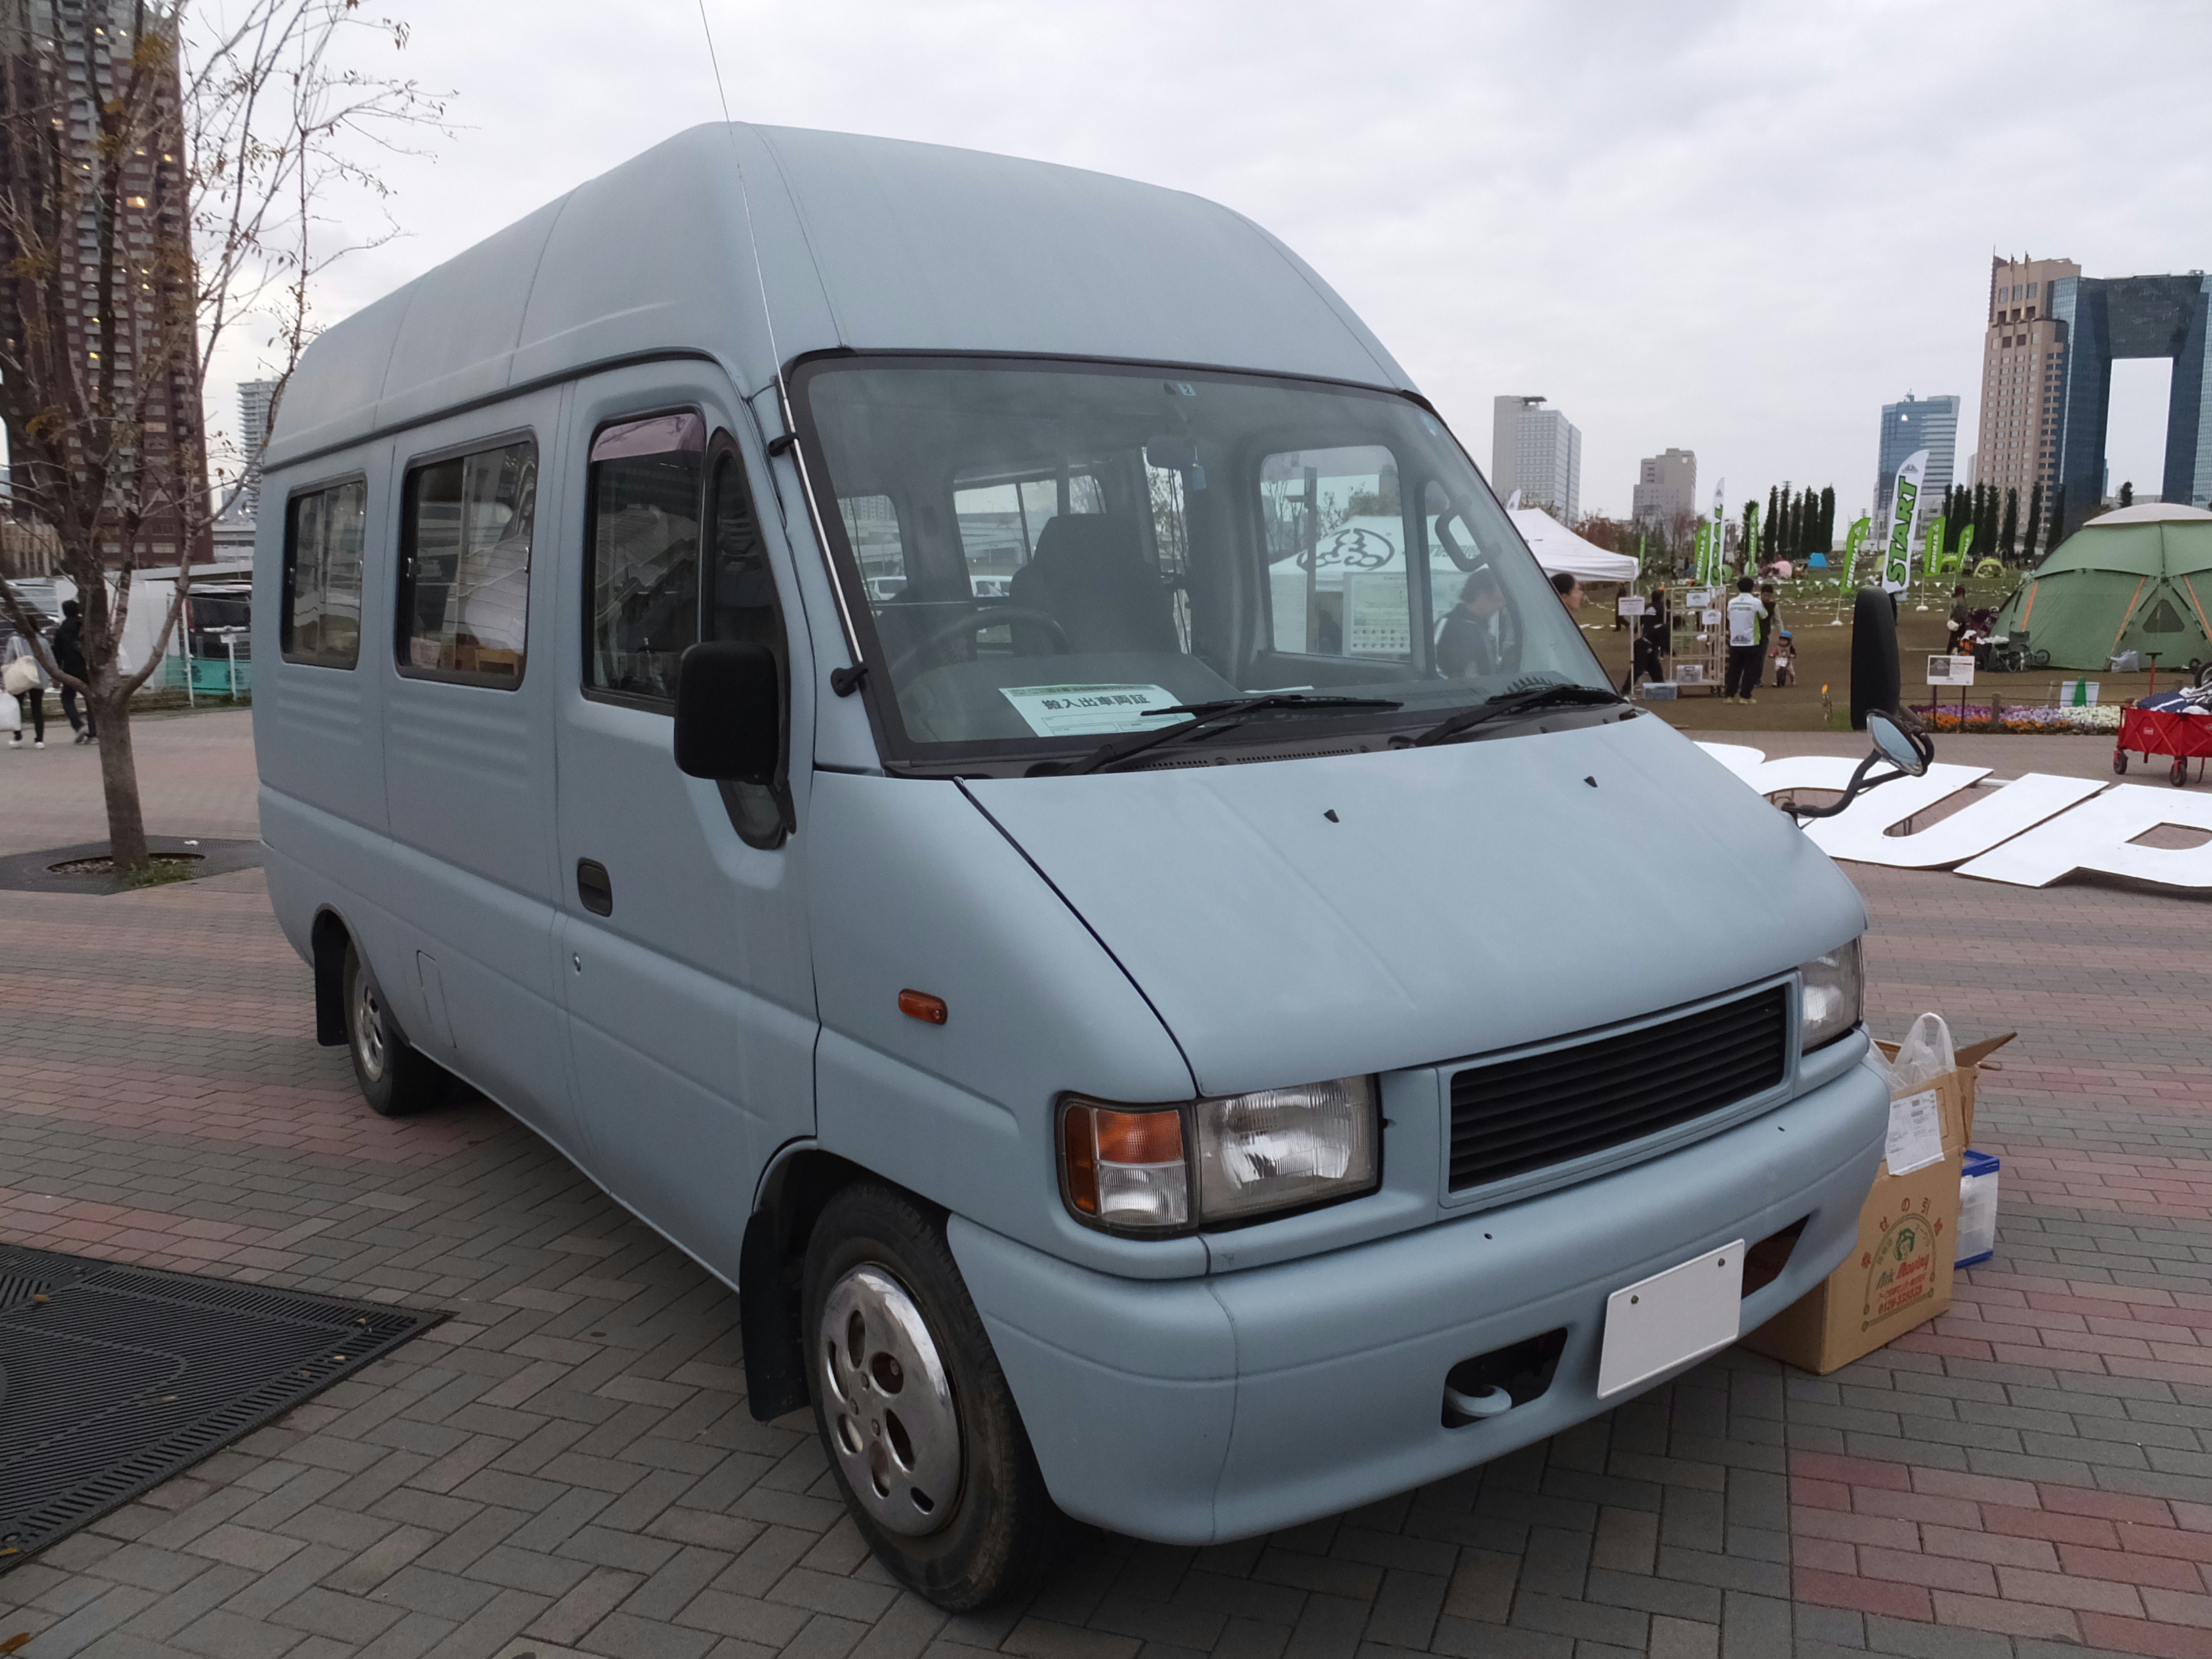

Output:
xmin=0 ymin=714 xmax=2212 ymax=1659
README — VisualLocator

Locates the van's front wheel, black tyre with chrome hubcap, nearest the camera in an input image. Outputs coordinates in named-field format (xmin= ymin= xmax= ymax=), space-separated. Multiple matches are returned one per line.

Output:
xmin=801 ymin=1181 xmax=1069 ymax=1612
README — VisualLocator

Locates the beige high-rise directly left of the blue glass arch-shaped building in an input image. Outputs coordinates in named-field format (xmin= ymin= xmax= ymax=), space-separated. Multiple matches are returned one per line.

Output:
xmin=1975 ymin=257 xmax=2104 ymax=546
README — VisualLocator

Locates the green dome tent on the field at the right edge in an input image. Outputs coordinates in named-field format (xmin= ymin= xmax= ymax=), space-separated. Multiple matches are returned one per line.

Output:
xmin=1997 ymin=502 xmax=2212 ymax=670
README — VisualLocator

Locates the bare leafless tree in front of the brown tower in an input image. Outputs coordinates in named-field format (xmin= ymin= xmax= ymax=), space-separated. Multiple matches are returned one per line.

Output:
xmin=0 ymin=0 xmax=445 ymax=872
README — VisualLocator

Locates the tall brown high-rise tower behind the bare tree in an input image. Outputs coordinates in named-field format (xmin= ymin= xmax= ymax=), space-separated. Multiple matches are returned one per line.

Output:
xmin=0 ymin=0 xmax=208 ymax=564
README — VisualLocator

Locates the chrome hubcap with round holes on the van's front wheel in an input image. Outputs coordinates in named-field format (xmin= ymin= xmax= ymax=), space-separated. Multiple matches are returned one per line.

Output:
xmin=814 ymin=1267 xmax=960 ymax=1537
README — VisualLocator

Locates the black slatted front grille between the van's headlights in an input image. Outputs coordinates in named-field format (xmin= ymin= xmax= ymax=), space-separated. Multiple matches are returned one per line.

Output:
xmin=1451 ymin=984 xmax=1790 ymax=1192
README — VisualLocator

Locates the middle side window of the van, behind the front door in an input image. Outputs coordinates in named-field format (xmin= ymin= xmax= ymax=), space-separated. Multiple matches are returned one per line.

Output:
xmin=394 ymin=441 xmax=537 ymax=690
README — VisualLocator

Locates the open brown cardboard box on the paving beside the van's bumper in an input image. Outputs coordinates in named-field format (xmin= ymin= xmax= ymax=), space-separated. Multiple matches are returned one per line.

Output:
xmin=1743 ymin=1033 xmax=2013 ymax=1374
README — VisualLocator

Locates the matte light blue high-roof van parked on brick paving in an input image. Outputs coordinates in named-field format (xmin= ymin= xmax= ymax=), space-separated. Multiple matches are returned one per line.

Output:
xmin=254 ymin=126 xmax=1887 ymax=1608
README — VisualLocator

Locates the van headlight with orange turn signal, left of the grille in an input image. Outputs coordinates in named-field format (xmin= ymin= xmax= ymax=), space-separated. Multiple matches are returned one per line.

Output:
xmin=1059 ymin=1078 xmax=1380 ymax=1234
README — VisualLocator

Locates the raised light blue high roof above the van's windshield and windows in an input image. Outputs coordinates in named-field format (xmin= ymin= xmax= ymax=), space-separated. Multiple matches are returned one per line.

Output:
xmin=266 ymin=124 xmax=1414 ymax=469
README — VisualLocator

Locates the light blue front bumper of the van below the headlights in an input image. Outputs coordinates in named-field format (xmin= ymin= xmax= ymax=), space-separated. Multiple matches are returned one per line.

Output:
xmin=949 ymin=1066 xmax=1889 ymax=1544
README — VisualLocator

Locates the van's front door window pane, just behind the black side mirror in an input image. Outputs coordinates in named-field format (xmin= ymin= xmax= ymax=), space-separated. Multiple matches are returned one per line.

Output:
xmin=584 ymin=411 xmax=705 ymax=703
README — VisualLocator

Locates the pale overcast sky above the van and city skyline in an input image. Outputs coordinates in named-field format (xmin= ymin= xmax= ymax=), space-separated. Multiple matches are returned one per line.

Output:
xmin=210 ymin=0 xmax=2212 ymax=526
